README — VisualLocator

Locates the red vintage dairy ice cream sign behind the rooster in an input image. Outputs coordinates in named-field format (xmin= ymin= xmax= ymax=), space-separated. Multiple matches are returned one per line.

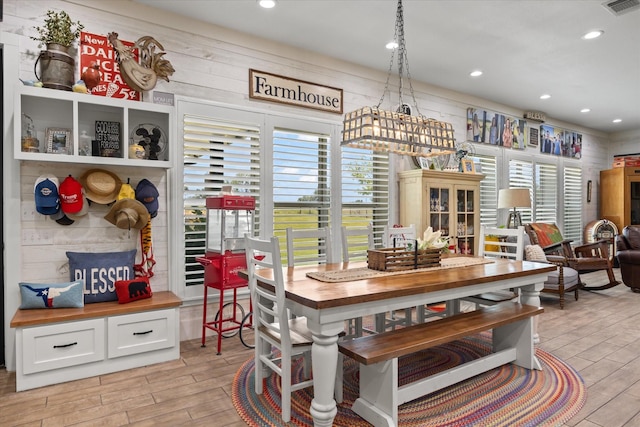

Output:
xmin=79 ymin=31 xmax=141 ymax=101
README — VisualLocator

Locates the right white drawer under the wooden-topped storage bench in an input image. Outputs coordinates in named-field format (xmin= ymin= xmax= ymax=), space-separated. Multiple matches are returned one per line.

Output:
xmin=107 ymin=309 xmax=176 ymax=358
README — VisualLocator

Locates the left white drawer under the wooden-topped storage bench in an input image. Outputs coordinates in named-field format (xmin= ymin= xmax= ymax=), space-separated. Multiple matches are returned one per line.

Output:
xmin=22 ymin=319 xmax=105 ymax=374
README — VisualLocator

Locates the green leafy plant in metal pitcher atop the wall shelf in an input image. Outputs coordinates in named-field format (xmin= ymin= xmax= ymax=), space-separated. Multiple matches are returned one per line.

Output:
xmin=31 ymin=10 xmax=84 ymax=90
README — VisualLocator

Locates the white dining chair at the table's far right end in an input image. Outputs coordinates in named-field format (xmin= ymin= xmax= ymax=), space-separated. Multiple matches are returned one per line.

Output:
xmin=463 ymin=225 xmax=525 ymax=307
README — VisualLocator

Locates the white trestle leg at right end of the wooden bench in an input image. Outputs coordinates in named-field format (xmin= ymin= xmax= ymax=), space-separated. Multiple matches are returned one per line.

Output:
xmin=493 ymin=317 xmax=542 ymax=370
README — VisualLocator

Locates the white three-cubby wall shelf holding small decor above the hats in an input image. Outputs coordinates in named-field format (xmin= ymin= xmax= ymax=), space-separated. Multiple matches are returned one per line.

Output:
xmin=14 ymin=86 xmax=175 ymax=168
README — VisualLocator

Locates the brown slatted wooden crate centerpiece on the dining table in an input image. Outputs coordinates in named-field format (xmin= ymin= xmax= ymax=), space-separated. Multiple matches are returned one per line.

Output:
xmin=367 ymin=247 xmax=442 ymax=271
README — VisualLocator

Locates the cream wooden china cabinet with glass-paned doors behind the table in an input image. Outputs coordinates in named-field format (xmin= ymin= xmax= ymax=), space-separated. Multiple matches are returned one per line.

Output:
xmin=398 ymin=169 xmax=484 ymax=254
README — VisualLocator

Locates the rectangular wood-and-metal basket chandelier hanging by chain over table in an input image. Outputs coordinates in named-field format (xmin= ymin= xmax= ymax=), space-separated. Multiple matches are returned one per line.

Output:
xmin=341 ymin=0 xmax=456 ymax=157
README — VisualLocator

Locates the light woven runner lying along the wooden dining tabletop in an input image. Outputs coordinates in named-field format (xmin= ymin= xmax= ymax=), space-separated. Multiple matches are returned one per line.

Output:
xmin=307 ymin=257 xmax=494 ymax=283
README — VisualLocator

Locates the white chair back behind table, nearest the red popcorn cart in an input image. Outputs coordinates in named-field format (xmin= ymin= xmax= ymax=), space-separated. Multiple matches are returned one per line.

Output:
xmin=286 ymin=227 xmax=332 ymax=267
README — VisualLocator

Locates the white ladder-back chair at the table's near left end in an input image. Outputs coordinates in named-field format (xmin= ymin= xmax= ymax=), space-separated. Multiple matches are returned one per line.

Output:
xmin=244 ymin=236 xmax=343 ymax=423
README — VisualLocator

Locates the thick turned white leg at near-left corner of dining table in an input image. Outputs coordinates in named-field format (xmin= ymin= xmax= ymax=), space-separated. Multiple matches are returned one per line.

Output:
xmin=310 ymin=333 xmax=338 ymax=427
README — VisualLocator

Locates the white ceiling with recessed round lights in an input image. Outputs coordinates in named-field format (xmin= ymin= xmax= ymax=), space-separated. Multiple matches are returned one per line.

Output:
xmin=134 ymin=0 xmax=640 ymax=133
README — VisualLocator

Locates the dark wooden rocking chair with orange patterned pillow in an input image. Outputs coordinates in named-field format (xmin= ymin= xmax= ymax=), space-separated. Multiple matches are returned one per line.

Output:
xmin=525 ymin=222 xmax=620 ymax=291
